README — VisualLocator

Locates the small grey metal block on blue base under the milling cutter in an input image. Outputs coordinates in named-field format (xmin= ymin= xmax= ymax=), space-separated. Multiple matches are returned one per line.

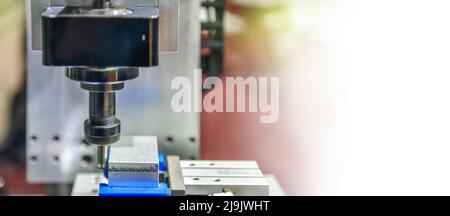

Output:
xmin=106 ymin=137 xmax=159 ymax=188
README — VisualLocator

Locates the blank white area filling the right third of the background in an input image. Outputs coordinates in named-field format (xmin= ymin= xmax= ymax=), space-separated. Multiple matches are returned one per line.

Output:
xmin=292 ymin=0 xmax=450 ymax=195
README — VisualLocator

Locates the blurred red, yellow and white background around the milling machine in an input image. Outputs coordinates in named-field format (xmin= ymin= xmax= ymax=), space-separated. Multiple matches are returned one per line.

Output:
xmin=0 ymin=0 xmax=450 ymax=195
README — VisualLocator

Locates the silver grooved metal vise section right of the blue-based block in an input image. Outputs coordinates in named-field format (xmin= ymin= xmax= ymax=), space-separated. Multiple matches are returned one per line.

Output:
xmin=180 ymin=161 xmax=269 ymax=196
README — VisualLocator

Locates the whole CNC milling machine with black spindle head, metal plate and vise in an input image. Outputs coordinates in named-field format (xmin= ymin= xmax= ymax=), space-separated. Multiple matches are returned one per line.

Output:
xmin=26 ymin=0 xmax=282 ymax=196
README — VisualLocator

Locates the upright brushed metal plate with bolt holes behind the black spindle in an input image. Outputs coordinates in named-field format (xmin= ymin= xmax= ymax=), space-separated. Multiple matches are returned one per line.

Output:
xmin=26 ymin=0 xmax=201 ymax=183
